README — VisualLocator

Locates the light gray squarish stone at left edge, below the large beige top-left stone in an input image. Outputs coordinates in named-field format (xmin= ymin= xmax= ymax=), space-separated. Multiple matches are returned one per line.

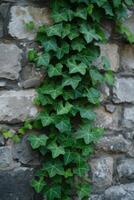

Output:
xmin=0 ymin=43 xmax=22 ymax=80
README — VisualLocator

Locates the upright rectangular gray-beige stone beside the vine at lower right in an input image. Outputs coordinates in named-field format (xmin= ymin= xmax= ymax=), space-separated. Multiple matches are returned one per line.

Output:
xmin=90 ymin=156 xmax=113 ymax=190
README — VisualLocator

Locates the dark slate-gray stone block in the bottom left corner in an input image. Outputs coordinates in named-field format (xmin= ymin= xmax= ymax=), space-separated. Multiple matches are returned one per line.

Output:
xmin=0 ymin=167 xmax=34 ymax=200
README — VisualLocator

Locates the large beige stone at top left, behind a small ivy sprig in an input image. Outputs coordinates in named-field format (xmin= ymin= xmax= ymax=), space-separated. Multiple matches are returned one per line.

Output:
xmin=9 ymin=6 xmax=50 ymax=40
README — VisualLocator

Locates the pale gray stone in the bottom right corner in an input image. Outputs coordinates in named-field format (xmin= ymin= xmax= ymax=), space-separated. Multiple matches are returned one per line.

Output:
xmin=105 ymin=183 xmax=134 ymax=200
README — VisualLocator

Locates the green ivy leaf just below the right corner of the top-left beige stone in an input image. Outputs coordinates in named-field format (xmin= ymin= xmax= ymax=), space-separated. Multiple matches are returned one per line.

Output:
xmin=46 ymin=23 xmax=63 ymax=37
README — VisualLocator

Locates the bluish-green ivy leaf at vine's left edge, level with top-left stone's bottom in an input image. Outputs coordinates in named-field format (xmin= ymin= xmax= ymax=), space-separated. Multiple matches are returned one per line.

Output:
xmin=42 ymin=38 xmax=58 ymax=52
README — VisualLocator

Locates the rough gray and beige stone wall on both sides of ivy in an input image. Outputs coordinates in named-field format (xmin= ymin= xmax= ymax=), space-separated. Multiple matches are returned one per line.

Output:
xmin=0 ymin=0 xmax=134 ymax=200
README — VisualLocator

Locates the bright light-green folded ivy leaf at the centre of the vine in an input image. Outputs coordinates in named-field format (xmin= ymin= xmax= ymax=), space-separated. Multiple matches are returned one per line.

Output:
xmin=57 ymin=102 xmax=73 ymax=115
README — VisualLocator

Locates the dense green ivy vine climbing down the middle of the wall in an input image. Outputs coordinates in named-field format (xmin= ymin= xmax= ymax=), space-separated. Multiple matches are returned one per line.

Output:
xmin=28 ymin=0 xmax=134 ymax=200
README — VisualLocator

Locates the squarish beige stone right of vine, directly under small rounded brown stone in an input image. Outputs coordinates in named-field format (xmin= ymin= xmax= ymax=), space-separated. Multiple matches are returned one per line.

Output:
xmin=95 ymin=107 xmax=120 ymax=129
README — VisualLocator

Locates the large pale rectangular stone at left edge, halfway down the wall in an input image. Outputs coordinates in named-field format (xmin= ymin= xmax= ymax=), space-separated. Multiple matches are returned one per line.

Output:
xmin=0 ymin=90 xmax=37 ymax=123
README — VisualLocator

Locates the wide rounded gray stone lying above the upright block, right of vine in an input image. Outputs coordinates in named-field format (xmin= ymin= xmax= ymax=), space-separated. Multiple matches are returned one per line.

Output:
xmin=96 ymin=135 xmax=132 ymax=153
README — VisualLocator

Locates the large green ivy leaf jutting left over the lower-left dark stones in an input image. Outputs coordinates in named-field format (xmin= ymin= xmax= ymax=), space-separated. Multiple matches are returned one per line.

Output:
xmin=28 ymin=134 xmax=48 ymax=149
